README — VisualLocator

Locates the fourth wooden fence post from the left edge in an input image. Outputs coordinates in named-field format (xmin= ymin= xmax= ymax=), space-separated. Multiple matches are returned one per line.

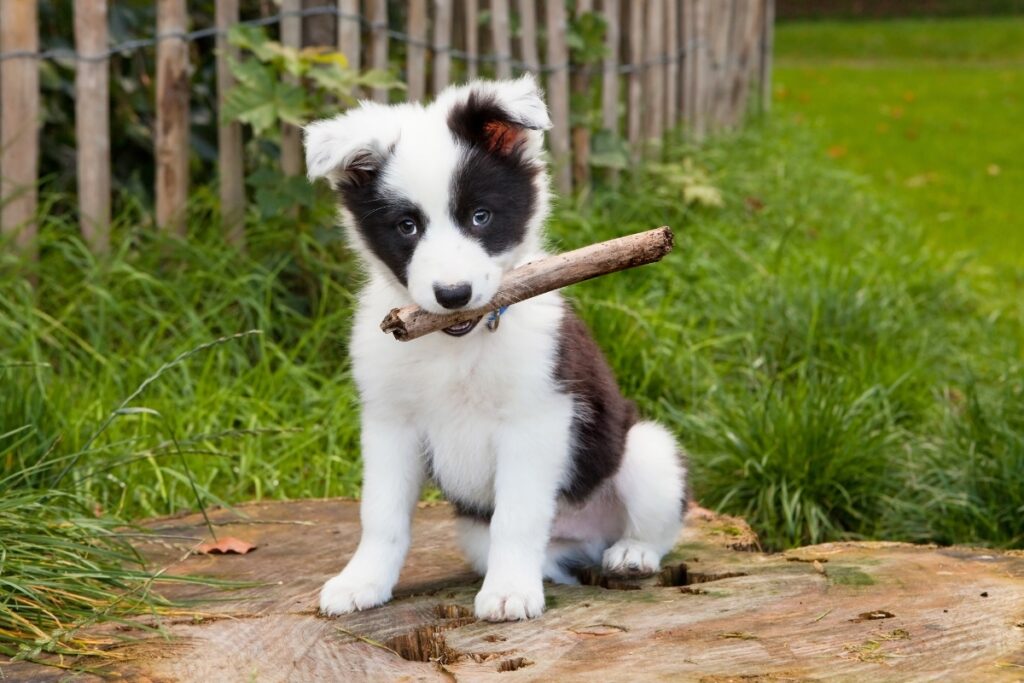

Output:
xmin=212 ymin=0 xmax=246 ymax=248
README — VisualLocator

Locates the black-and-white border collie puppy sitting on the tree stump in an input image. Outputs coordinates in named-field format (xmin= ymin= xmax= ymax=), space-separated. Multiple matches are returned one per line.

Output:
xmin=305 ymin=77 xmax=686 ymax=621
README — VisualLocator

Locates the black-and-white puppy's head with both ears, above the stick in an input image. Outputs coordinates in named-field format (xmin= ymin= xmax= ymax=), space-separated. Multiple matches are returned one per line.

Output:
xmin=305 ymin=76 xmax=551 ymax=312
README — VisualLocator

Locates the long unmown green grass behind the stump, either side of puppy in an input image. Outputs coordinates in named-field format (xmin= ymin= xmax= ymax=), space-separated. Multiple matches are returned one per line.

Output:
xmin=0 ymin=124 xmax=1024 ymax=548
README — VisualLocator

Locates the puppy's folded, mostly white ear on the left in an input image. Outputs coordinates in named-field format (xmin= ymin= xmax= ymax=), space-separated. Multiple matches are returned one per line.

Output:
xmin=304 ymin=102 xmax=400 ymax=188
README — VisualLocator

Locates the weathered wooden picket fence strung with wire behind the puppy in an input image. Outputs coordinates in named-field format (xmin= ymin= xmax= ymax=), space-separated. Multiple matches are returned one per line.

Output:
xmin=0 ymin=0 xmax=774 ymax=255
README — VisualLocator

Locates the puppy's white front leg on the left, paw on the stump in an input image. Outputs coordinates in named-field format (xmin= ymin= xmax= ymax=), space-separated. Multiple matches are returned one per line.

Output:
xmin=319 ymin=414 xmax=424 ymax=614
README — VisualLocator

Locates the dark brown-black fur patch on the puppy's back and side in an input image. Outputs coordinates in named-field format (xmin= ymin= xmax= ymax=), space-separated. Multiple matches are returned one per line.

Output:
xmin=555 ymin=304 xmax=637 ymax=503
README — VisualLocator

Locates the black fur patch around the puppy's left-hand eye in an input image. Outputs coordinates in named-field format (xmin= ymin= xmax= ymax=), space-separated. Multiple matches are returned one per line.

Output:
xmin=338 ymin=160 xmax=427 ymax=285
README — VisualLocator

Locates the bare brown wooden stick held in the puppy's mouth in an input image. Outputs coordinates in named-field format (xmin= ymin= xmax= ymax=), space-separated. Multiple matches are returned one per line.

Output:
xmin=381 ymin=225 xmax=674 ymax=341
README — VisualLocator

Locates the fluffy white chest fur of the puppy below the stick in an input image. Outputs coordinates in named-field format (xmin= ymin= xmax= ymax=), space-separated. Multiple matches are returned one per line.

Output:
xmin=351 ymin=276 xmax=571 ymax=508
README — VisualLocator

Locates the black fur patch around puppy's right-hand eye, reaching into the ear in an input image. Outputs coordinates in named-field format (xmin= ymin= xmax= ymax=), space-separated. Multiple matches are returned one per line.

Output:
xmin=449 ymin=93 xmax=542 ymax=255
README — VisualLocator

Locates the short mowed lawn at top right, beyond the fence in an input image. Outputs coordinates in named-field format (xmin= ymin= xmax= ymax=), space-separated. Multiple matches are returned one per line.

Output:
xmin=774 ymin=16 xmax=1024 ymax=270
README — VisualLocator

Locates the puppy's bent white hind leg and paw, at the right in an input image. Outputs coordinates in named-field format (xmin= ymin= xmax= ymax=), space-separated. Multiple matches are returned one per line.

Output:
xmin=602 ymin=422 xmax=686 ymax=575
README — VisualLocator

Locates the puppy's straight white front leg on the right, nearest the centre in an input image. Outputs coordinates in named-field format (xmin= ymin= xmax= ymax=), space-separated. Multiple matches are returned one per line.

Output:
xmin=476 ymin=398 xmax=572 ymax=622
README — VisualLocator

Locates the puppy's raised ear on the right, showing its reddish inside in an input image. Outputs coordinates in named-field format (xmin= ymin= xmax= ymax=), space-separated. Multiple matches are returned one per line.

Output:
xmin=437 ymin=74 xmax=551 ymax=158
